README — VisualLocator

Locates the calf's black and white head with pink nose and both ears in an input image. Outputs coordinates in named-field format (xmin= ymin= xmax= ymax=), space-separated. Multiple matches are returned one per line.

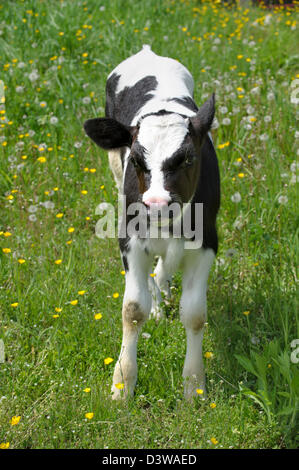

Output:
xmin=84 ymin=94 xmax=215 ymax=209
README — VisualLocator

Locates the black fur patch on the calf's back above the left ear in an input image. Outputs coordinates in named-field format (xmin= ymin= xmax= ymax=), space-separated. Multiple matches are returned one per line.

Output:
xmin=105 ymin=73 xmax=158 ymax=125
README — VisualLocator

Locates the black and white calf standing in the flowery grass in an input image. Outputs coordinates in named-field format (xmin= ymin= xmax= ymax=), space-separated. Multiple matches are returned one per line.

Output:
xmin=84 ymin=46 xmax=220 ymax=398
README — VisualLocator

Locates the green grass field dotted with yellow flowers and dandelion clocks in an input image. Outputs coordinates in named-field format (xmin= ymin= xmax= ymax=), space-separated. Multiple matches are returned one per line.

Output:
xmin=0 ymin=0 xmax=299 ymax=449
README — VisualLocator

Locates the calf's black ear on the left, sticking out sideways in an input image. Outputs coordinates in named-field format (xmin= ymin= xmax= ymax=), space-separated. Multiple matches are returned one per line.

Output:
xmin=84 ymin=118 xmax=136 ymax=150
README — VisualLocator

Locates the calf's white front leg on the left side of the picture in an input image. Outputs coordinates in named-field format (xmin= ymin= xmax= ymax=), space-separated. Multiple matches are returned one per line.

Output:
xmin=112 ymin=240 xmax=151 ymax=399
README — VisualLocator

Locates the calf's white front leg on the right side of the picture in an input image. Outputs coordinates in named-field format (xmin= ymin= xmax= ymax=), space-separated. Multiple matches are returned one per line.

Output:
xmin=180 ymin=248 xmax=215 ymax=399
